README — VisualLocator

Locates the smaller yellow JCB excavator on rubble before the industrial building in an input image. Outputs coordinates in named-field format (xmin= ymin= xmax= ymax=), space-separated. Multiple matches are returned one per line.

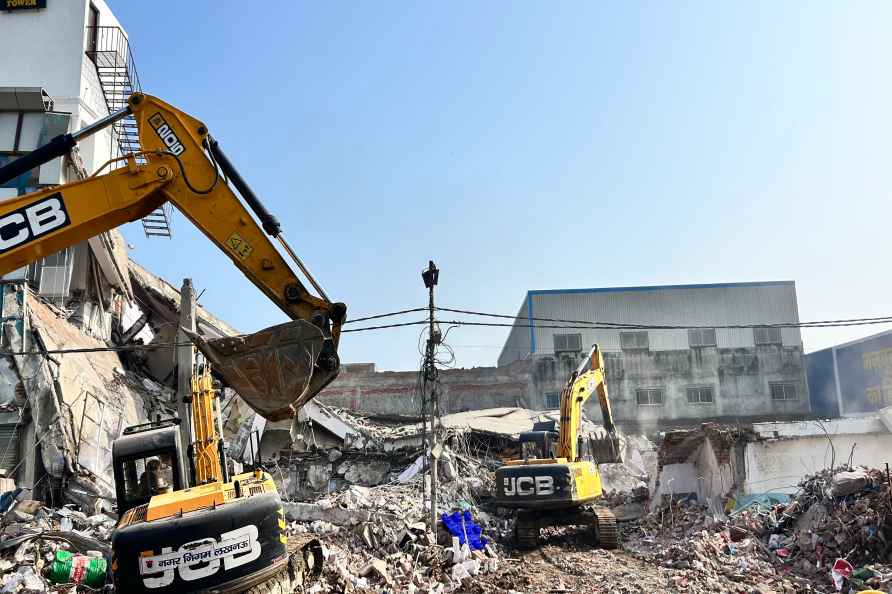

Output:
xmin=496 ymin=345 xmax=622 ymax=549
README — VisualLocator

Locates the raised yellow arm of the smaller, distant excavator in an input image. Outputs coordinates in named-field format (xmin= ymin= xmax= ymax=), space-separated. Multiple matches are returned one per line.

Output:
xmin=556 ymin=345 xmax=621 ymax=462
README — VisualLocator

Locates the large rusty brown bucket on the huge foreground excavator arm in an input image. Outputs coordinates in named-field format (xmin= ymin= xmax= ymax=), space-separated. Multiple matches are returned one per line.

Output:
xmin=183 ymin=320 xmax=338 ymax=421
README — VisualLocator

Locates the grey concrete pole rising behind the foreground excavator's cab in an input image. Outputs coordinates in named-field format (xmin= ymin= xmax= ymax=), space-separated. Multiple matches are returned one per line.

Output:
xmin=176 ymin=278 xmax=195 ymax=487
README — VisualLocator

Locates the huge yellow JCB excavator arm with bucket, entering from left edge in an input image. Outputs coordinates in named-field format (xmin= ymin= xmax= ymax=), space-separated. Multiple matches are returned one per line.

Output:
xmin=0 ymin=93 xmax=346 ymax=420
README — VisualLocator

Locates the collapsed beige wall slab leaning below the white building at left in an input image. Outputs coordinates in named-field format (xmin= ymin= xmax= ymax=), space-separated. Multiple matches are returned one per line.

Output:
xmin=5 ymin=285 xmax=169 ymax=509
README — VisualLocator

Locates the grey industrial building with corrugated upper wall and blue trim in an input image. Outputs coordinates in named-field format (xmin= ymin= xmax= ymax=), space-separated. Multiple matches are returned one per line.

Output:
xmin=498 ymin=281 xmax=810 ymax=427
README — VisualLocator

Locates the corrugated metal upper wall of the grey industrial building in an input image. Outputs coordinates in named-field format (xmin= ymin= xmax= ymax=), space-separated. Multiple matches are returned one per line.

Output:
xmin=499 ymin=282 xmax=802 ymax=358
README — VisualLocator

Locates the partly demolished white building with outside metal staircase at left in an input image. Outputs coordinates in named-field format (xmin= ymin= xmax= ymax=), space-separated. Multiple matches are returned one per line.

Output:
xmin=0 ymin=0 xmax=239 ymax=509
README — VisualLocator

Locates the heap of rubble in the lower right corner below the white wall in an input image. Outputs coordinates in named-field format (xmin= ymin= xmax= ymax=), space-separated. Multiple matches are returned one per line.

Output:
xmin=606 ymin=468 xmax=892 ymax=592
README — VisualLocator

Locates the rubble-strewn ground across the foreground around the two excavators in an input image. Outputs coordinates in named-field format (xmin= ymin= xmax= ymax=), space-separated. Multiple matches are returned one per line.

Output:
xmin=6 ymin=402 xmax=892 ymax=594
